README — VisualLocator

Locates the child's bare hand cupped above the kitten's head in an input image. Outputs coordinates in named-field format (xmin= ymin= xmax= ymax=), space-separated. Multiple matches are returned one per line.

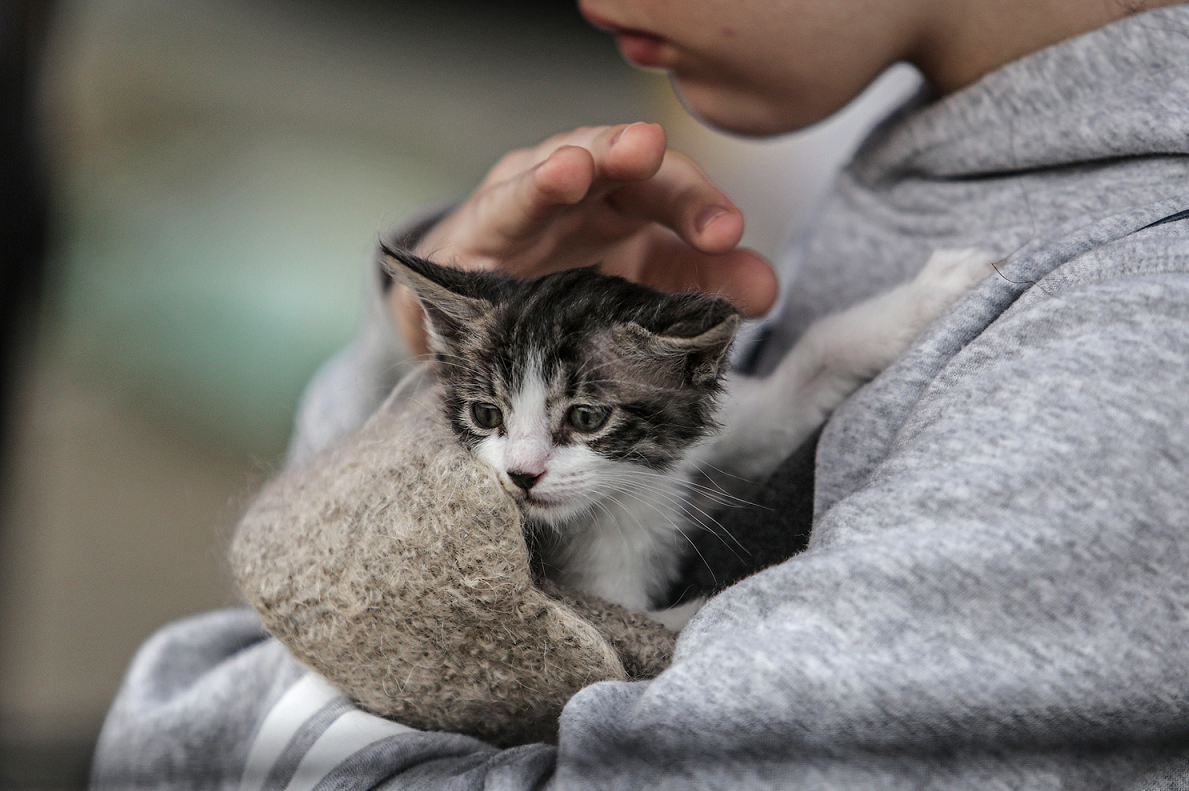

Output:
xmin=392 ymin=124 xmax=776 ymax=352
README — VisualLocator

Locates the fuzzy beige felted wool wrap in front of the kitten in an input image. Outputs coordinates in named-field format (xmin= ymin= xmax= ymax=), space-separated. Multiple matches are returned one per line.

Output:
xmin=231 ymin=372 xmax=674 ymax=745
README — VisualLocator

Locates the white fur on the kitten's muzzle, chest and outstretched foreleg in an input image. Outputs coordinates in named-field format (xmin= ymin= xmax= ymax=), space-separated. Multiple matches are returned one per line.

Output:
xmin=477 ymin=250 xmax=995 ymax=621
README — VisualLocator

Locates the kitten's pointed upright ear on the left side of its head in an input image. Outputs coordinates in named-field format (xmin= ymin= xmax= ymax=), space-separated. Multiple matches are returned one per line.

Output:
xmin=380 ymin=244 xmax=491 ymax=346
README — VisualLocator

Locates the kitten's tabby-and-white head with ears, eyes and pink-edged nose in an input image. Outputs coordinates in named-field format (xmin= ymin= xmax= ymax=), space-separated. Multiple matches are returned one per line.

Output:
xmin=384 ymin=249 xmax=738 ymax=525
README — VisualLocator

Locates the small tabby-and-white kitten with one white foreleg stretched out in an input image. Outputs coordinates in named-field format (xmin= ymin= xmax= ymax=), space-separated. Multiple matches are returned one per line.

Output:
xmin=384 ymin=247 xmax=992 ymax=610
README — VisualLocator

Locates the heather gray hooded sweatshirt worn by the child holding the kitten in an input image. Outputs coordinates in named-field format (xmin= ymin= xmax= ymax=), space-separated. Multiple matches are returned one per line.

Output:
xmin=96 ymin=7 xmax=1189 ymax=790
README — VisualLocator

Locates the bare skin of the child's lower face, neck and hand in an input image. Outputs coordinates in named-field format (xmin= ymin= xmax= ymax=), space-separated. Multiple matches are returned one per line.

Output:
xmin=390 ymin=0 xmax=1181 ymax=353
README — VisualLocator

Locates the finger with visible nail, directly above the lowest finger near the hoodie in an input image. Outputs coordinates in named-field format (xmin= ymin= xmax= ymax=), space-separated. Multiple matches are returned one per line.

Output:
xmin=606 ymin=151 xmax=743 ymax=253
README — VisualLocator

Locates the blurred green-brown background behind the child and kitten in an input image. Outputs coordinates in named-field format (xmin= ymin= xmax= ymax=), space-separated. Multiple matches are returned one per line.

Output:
xmin=0 ymin=0 xmax=916 ymax=789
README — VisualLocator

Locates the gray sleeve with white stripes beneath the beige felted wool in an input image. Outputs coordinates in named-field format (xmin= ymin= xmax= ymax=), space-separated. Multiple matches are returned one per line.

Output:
xmin=90 ymin=609 xmax=554 ymax=791
